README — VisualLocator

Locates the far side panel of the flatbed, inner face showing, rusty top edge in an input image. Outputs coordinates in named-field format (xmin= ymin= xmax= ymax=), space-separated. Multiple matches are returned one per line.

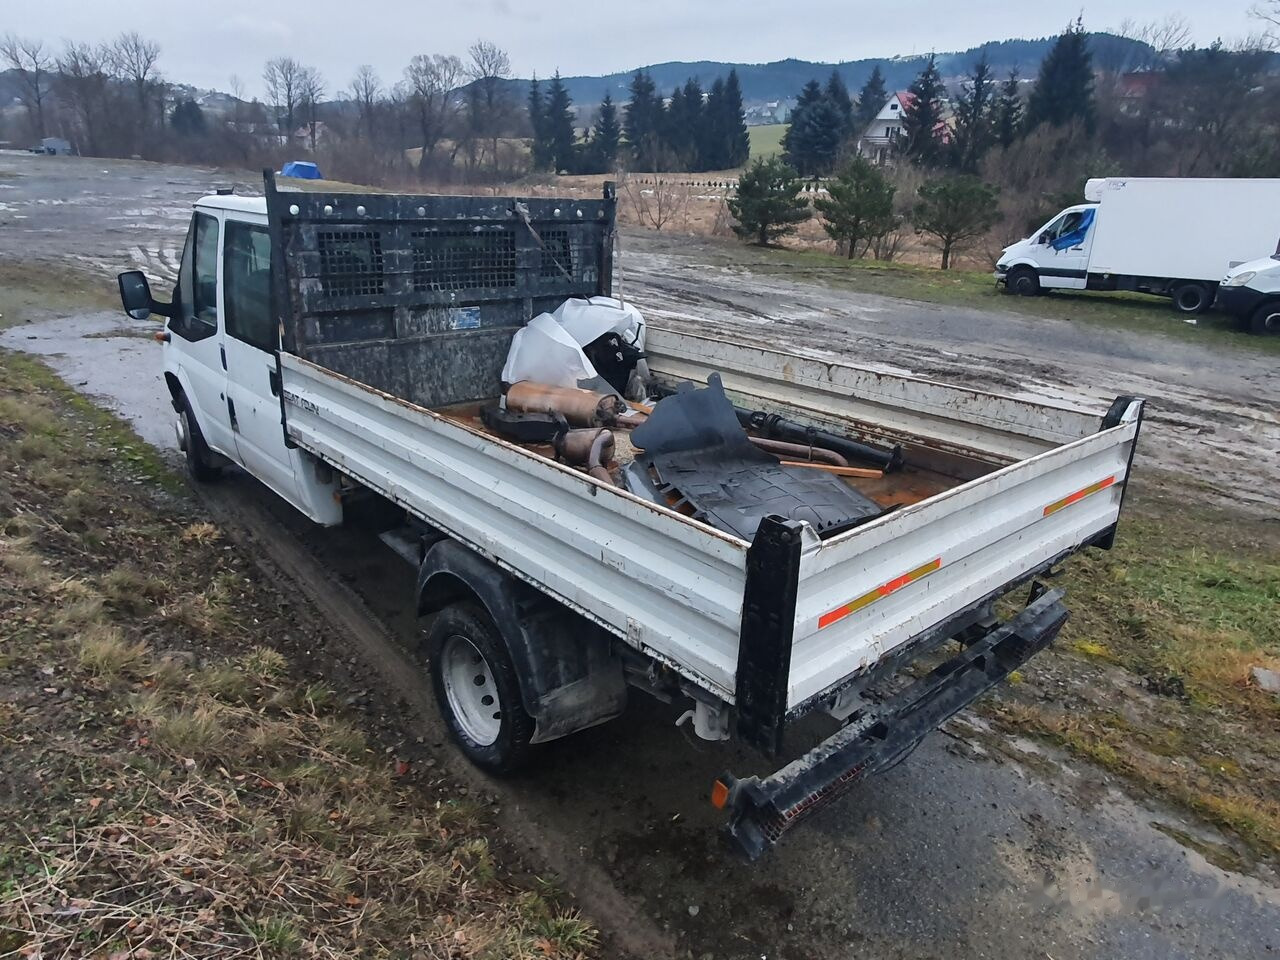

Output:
xmin=645 ymin=328 xmax=1098 ymax=462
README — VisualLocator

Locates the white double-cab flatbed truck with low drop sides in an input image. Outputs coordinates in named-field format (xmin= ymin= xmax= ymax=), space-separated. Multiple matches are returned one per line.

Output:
xmin=120 ymin=174 xmax=1143 ymax=858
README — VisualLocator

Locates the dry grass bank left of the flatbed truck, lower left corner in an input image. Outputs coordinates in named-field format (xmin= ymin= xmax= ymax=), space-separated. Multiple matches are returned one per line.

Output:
xmin=0 ymin=353 xmax=596 ymax=960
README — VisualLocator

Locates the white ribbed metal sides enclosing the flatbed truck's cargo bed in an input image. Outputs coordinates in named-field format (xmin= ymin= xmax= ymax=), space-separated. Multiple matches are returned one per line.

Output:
xmin=280 ymin=330 xmax=1142 ymax=713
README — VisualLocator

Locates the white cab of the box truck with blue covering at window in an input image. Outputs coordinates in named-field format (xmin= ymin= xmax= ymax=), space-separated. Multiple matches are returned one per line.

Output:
xmin=996 ymin=204 xmax=1098 ymax=297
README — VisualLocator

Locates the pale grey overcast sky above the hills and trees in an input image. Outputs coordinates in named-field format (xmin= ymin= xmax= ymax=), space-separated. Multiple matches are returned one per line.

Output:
xmin=10 ymin=0 xmax=1257 ymax=95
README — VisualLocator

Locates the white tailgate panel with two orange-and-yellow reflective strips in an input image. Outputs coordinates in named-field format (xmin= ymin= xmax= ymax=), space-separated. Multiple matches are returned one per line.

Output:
xmin=787 ymin=422 xmax=1138 ymax=707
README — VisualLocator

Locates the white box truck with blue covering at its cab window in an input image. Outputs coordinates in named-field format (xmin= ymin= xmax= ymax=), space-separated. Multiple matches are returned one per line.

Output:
xmin=996 ymin=177 xmax=1280 ymax=314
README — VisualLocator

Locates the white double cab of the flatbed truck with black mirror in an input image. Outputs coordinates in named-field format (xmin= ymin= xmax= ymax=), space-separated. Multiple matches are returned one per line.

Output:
xmin=120 ymin=195 xmax=342 ymax=525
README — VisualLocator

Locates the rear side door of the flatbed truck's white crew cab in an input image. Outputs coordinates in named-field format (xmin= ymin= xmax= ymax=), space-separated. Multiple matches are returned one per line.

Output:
xmin=221 ymin=218 xmax=298 ymax=503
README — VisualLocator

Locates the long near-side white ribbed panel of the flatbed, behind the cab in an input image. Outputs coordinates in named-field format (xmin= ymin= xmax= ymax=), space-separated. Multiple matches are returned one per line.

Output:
xmin=280 ymin=355 xmax=746 ymax=700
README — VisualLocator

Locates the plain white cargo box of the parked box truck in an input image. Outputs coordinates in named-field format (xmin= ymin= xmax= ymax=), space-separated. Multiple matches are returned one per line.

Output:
xmin=1088 ymin=177 xmax=1280 ymax=283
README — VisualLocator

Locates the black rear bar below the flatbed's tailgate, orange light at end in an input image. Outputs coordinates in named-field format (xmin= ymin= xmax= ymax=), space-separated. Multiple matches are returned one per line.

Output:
xmin=712 ymin=584 xmax=1069 ymax=860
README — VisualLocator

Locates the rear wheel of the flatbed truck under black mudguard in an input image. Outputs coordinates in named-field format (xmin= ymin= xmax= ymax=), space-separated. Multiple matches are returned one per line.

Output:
xmin=426 ymin=603 xmax=534 ymax=776
